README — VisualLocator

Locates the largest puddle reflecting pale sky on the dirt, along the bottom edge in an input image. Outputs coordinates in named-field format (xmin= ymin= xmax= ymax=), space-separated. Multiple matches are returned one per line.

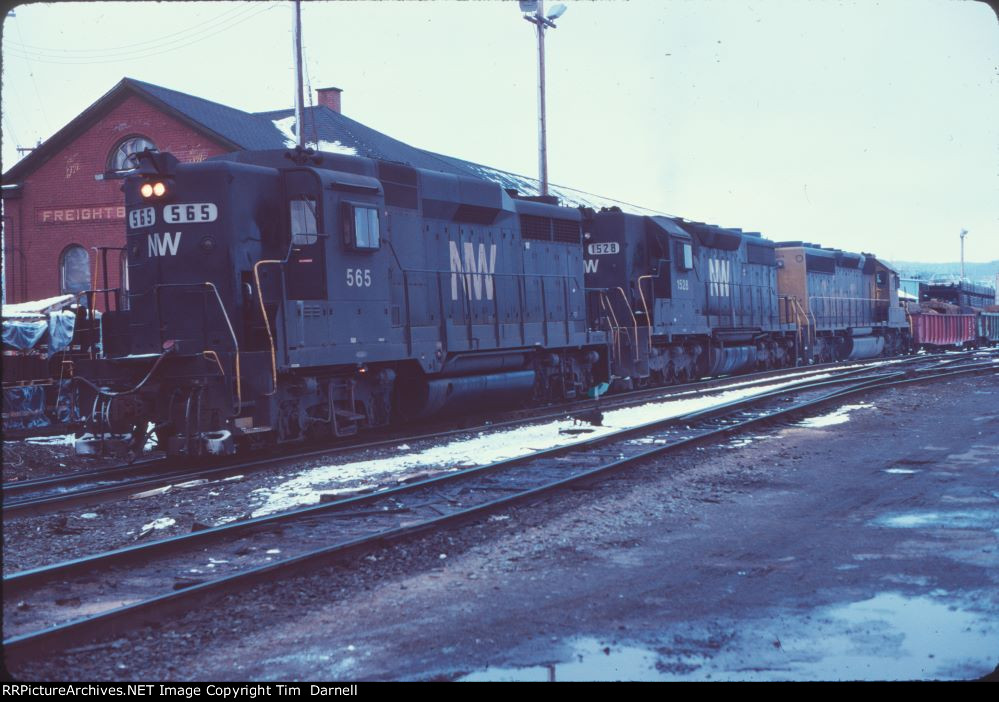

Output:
xmin=459 ymin=593 xmax=999 ymax=682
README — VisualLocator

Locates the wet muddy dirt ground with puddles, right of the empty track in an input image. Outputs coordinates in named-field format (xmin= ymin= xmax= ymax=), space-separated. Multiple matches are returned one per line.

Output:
xmin=3 ymin=376 xmax=999 ymax=680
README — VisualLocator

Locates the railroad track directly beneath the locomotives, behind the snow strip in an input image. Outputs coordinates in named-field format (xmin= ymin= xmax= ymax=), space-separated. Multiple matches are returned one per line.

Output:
xmin=3 ymin=354 xmax=973 ymax=519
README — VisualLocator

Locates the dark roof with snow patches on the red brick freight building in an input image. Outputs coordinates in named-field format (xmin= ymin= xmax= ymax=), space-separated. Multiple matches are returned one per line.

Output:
xmin=3 ymin=78 xmax=665 ymax=214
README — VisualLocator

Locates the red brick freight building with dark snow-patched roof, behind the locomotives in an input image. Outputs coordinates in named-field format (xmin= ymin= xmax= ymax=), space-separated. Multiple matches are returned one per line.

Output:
xmin=2 ymin=78 xmax=648 ymax=303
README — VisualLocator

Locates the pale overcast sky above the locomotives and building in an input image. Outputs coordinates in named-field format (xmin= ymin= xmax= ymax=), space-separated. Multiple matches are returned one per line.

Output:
xmin=2 ymin=0 xmax=999 ymax=262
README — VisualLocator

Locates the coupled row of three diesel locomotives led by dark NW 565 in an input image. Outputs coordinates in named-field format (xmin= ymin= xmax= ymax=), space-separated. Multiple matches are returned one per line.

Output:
xmin=70 ymin=149 xmax=909 ymax=456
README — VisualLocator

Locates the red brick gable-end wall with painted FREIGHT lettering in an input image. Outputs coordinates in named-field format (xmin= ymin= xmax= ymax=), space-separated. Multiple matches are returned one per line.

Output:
xmin=3 ymin=95 xmax=227 ymax=303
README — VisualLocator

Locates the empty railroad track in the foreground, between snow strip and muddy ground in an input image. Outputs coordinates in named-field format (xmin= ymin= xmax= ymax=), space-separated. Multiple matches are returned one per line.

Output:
xmin=3 ymin=358 xmax=997 ymax=658
